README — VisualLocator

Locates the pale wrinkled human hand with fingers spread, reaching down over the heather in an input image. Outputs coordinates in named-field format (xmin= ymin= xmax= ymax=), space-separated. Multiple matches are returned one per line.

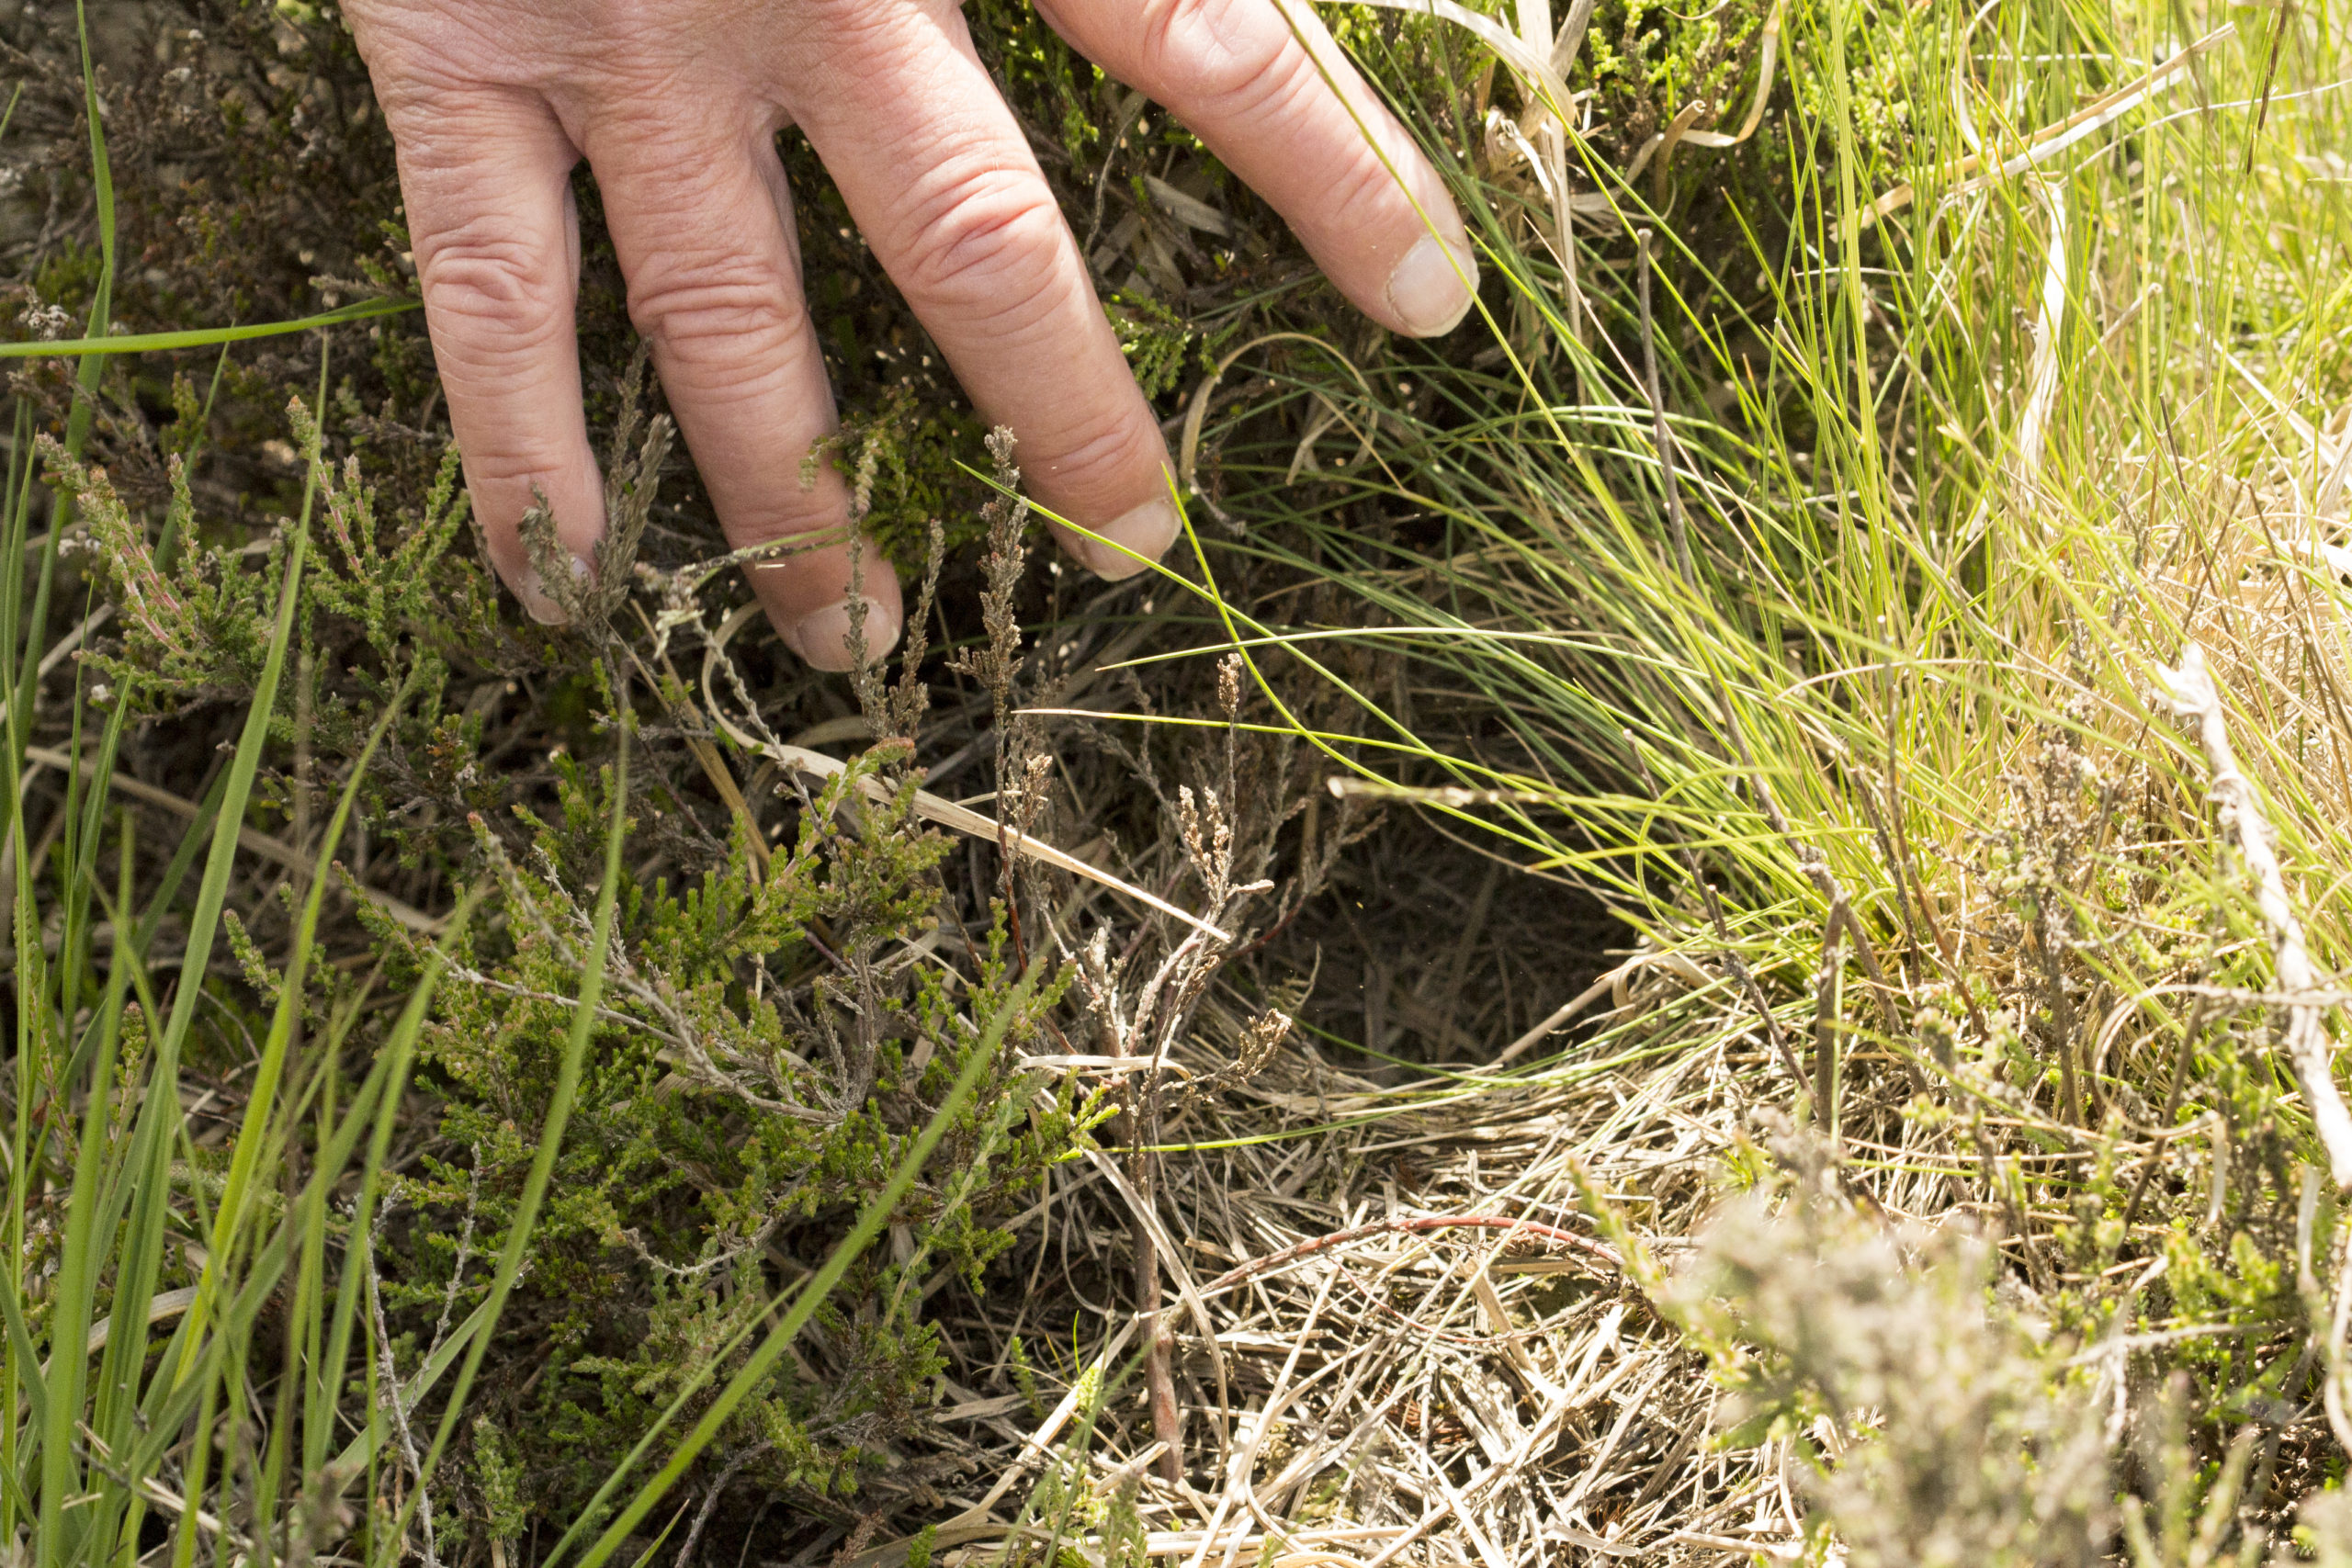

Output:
xmin=345 ymin=0 xmax=1477 ymax=670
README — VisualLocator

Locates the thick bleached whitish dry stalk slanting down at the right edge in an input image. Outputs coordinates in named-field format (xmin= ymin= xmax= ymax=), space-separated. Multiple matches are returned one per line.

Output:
xmin=2164 ymin=642 xmax=2352 ymax=1190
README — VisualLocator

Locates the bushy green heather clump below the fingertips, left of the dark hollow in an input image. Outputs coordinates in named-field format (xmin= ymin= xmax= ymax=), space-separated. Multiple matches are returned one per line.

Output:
xmin=386 ymin=752 xmax=1105 ymax=1518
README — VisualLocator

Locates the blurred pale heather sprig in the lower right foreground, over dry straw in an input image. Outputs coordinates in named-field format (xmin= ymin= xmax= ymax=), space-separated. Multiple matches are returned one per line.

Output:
xmin=1670 ymin=1134 xmax=2126 ymax=1568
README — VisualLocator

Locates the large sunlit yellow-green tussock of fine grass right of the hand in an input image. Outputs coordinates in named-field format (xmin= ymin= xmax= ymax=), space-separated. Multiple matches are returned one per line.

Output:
xmin=1161 ymin=3 xmax=2352 ymax=1161
